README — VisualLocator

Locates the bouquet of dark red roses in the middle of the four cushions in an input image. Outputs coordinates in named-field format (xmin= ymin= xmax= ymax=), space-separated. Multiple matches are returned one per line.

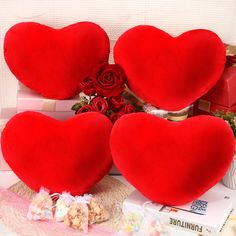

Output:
xmin=72 ymin=64 xmax=140 ymax=123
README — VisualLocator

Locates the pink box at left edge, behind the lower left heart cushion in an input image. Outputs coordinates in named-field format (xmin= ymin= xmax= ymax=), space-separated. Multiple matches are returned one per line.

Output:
xmin=0 ymin=108 xmax=16 ymax=171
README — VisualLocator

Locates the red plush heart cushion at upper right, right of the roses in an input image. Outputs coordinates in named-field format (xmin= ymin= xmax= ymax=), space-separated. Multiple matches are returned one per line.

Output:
xmin=114 ymin=26 xmax=225 ymax=110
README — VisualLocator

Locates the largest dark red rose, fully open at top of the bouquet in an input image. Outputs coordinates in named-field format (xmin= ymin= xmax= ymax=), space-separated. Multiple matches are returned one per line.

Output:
xmin=93 ymin=64 xmax=125 ymax=97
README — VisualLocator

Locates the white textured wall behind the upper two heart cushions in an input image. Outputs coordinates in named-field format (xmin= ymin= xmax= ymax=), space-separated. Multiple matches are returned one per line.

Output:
xmin=0 ymin=0 xmax=236 ymax=107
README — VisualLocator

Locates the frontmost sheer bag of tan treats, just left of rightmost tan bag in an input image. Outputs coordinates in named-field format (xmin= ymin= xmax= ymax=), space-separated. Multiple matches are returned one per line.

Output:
xmin=64 ymin=196 xmax=89 ymax=233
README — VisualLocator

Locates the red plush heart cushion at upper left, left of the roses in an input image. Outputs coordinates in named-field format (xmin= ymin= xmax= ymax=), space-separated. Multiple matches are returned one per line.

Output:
xmin=4 ymin=22 xmax=110 ymax=99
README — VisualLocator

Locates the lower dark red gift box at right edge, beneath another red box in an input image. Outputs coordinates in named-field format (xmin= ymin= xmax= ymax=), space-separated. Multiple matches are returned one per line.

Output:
xmin=193 ymin=98 xmax=236 ymax=115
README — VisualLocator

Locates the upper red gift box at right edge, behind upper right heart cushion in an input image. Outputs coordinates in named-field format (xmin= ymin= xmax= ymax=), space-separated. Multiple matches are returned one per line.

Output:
xmin=202 ymin=66 xmax=236 ymax=107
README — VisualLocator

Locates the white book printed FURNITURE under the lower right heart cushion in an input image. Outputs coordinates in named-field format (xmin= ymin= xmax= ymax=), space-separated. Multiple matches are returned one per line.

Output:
xmin=122 ymin=188 xmax=233 ymax=236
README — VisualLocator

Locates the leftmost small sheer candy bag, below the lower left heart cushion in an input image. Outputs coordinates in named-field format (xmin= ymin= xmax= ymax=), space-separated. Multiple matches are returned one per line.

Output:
xmin=27 ymin=188 xmax=53 ymax=221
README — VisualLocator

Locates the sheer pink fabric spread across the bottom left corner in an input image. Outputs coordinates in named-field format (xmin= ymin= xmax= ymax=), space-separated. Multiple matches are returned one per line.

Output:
xmin=0 ymin=188 xmax=115 ymax=236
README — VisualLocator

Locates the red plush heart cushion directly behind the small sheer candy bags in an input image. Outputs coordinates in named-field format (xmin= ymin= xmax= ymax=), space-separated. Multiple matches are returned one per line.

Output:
xmin=1 ymin=112 xmax=112 ymax=195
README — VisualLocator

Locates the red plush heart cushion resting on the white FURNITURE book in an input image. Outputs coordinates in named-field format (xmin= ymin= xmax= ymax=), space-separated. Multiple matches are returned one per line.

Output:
xmin=111 ymin=113 xmax=235 ymax=205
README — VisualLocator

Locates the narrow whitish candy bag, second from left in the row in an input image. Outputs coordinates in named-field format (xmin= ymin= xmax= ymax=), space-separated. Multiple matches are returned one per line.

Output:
xmin=54 ymin=192 xmax=74 ymax=221
